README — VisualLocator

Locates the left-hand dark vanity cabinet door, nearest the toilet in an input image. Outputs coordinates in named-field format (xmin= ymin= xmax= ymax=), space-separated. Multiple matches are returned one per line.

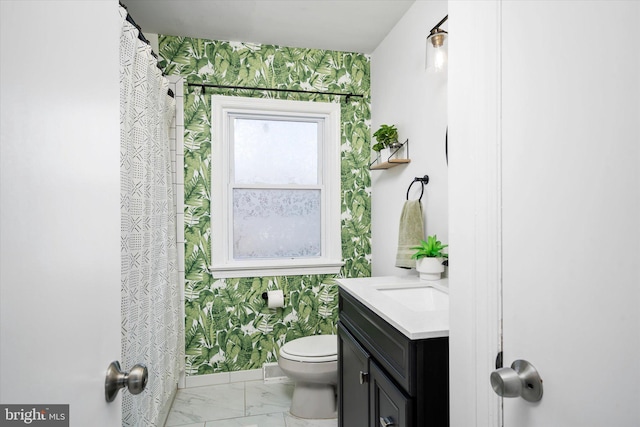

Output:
xmin=338 ymin=323 xmax=369 ymax=427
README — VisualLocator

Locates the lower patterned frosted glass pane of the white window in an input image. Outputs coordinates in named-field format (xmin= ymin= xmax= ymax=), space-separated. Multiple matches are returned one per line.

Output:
xmin=233 ymin=189 xmax=321 ymax=259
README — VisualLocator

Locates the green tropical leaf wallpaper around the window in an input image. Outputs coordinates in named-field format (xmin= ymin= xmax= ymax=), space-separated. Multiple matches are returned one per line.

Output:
xmin=159 ymin=36 xmax=371 ymax=375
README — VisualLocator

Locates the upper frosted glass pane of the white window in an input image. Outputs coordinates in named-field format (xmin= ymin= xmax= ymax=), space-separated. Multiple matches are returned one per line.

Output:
xmin=233 ymin=118 xmax=319 ymax=185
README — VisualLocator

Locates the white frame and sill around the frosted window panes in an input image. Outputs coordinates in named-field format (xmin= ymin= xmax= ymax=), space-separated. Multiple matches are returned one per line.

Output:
xmin=209 ymin=95 xmax=344 ymax=278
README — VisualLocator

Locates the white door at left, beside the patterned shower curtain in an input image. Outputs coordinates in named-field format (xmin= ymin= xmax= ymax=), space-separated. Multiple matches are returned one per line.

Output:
xmin=0 ymin=1 xmax=121 ymax=427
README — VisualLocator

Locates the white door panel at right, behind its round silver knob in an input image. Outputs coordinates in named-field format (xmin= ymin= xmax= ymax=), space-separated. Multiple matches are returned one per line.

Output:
xmin=502 ymin=1 xmax=640 ymax=427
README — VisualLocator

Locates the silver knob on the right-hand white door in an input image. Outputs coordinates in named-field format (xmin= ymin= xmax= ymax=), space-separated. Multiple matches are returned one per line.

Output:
xmin=491 ymin=360 xmax=542 ymax=402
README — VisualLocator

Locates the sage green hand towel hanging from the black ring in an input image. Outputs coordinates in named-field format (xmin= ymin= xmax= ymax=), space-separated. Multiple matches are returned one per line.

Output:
xmin=396 ymin=200 xmax=424 ymax=268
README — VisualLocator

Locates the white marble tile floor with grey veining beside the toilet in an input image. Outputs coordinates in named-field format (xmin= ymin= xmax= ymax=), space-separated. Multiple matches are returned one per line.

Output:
xmin=165 ymin=381 xmax=338 ymax=427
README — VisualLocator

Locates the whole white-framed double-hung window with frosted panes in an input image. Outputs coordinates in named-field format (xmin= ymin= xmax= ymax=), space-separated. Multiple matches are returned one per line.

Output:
xmin=211 ymin=96 xmax=343 ymax=278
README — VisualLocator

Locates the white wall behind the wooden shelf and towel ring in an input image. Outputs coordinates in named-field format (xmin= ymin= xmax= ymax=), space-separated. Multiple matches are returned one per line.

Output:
xmin=371 ymin=1 xmax=448 ymax=276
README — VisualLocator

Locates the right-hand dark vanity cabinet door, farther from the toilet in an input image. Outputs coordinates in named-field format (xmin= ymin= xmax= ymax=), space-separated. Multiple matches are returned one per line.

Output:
xmin=369 ymin=361 xmax=413 ymax=427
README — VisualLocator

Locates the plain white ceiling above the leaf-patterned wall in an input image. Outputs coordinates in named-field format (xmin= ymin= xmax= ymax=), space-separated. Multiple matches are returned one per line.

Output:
xmin=121 ymin=0 xmax=415 ymax=53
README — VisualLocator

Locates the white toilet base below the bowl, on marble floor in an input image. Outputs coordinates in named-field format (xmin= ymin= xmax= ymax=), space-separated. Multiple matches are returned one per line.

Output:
xmin=290 ymin=381 xmax=338 ymax=419
